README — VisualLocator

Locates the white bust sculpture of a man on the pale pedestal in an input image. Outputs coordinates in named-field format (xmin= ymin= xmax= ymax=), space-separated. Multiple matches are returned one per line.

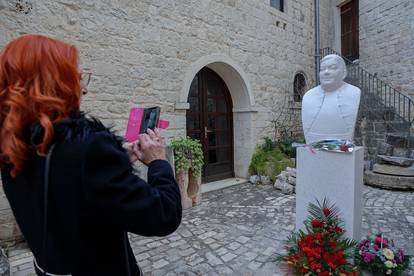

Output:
xmin=302 ymin=55 xmax=361 ymax=144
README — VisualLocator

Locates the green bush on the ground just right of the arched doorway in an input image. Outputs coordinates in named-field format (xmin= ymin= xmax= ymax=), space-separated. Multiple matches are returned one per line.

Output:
xmin=249 ymin=138 xmax=293 ymax=181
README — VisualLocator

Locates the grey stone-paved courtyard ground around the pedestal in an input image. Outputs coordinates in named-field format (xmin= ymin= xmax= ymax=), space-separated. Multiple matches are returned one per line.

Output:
xmin=6 ymin=184 xmax=414 ymax=275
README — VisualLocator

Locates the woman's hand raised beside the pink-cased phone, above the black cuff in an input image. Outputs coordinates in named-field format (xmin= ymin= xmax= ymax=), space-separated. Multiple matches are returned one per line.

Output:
xmin=134 ymin=128 xmax=167 ymax=165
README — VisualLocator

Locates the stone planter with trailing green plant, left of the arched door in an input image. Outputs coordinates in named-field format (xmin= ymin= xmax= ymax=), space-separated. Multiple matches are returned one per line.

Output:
xmin=171 ymin=137 xmax=204 ymax=208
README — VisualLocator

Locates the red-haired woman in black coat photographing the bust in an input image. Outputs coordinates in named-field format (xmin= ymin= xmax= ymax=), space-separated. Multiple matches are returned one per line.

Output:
xmin=0 ymin=35 xmax=182 ymax=275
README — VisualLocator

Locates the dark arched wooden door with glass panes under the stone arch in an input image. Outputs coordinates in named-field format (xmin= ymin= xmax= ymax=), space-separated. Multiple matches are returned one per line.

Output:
xmin=186 ymin=67 xmax=234 ymax=182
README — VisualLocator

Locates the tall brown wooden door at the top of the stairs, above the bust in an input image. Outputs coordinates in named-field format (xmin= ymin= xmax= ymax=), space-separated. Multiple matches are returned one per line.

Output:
xmin=341 ymin=0 xmax=359 ymax=60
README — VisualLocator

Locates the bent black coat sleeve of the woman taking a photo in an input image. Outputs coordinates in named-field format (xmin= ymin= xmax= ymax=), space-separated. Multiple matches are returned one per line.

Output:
xmin=83 ymin=132 xmax=182 ymax=236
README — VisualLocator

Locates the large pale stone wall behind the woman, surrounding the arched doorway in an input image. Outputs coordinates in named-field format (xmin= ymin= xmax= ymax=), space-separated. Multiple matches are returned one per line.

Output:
xmin=0 ymin=0 xmax=325 ymax=245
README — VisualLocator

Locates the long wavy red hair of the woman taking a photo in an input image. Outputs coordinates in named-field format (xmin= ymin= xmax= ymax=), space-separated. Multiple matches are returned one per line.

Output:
xmin=0 ymin=35 xmax=81 ymax=177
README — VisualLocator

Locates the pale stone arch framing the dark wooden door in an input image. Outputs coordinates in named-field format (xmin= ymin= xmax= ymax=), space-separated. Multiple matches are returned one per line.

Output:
xmin=176 ymin=54 xmax=257 ymax=177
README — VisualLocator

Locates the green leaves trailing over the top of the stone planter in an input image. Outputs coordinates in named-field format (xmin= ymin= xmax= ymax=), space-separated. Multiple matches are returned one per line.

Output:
xmin=171 ymin=137 xmax=204 ymax=176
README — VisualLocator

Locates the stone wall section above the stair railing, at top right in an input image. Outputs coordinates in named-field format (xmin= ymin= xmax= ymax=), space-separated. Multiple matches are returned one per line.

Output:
xmin=359 ymin=0 xmax=414 ymax=97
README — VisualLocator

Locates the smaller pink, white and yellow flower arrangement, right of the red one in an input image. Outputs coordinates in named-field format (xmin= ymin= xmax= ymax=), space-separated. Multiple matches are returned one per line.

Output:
xmin=355 ymin=234 xmax=410 ymax=275
